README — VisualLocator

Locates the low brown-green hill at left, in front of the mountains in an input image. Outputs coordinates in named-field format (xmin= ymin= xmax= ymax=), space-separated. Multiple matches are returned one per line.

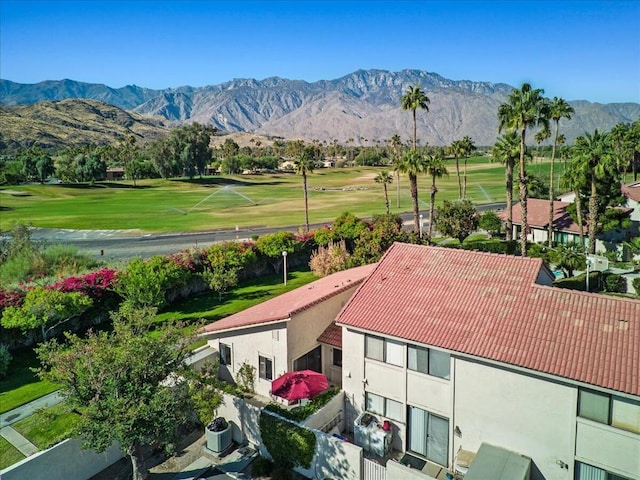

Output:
xmin=0 ymin=99 xmax=170 ymax=149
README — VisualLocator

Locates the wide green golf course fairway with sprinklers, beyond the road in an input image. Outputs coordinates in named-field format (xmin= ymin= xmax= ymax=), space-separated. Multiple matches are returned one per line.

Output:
xmin=0 ymin=157 xmax=560 ymax=232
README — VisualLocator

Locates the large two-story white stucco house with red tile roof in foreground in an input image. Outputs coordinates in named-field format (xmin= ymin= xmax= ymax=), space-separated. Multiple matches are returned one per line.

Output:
xmin=336 ymin=243 xmax=640 ymax=480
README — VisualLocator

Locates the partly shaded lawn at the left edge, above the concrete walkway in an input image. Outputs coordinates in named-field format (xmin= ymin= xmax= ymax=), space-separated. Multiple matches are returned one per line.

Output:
xmin=0 ymin=349 xmax=58 ymax=413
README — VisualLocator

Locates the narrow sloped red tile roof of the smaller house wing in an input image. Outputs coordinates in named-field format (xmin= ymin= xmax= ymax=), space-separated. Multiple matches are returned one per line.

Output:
xmin=201 ymin=264 xmax=375 ymax=334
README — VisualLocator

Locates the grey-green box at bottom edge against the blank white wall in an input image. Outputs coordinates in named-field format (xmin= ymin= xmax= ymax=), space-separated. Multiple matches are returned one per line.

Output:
xmin=464 ymin=443 xmax=531 ymax=480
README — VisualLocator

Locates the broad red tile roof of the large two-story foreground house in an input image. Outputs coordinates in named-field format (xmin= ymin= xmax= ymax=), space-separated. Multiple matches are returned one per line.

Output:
xmin=336 ymin=243 xmax=640 ymax=395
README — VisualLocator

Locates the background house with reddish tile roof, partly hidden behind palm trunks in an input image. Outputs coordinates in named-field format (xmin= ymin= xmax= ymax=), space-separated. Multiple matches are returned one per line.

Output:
xmin=500 ymin=198 xmax=633 ymax=252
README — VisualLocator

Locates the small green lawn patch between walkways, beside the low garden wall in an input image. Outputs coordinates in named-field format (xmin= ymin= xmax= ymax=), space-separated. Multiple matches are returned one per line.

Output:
xmin=11 ymin=403 xmax=78 ymax=450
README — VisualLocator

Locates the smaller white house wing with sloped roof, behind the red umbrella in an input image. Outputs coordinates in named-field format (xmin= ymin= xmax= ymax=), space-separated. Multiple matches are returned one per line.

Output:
xmin=201 ymin=265 xmax=375 ymax=397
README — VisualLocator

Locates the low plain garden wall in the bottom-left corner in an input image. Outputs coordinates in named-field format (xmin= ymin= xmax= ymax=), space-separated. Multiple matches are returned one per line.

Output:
xmin=0 ymin=439 xmax=123 ymax=480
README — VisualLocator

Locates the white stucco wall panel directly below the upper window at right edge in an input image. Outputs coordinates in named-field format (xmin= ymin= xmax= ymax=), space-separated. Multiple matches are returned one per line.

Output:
xmin=576 ymin=418 xmax=640 ymax=480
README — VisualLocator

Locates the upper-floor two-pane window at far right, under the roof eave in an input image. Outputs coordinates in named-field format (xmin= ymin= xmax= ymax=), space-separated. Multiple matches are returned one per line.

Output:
xmin=578 ymin=389 xmax=640 ymax=433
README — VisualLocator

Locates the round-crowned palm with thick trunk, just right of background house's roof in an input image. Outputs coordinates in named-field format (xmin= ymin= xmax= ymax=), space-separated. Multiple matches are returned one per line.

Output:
xmin=573 ymin=129 xmax=612 ymax=255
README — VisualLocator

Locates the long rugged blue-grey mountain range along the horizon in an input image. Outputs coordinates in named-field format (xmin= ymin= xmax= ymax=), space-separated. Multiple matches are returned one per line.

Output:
xmin=0 ymin=70 xmax=640 ymax=145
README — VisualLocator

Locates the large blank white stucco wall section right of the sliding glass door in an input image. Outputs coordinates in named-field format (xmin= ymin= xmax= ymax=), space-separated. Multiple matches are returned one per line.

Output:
xmin=451 ymin=358 xmax=578 ymax=480
